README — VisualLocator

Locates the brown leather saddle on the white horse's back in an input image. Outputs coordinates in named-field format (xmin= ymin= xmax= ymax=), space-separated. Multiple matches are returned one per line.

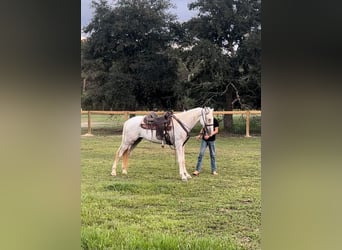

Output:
xmin=140 ymin=111 xmax=173 ymax=145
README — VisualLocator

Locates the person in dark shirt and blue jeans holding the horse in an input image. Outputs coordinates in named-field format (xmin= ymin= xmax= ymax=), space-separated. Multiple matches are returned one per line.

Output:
xmin=192 ymin=118 xmax=219 ymax=176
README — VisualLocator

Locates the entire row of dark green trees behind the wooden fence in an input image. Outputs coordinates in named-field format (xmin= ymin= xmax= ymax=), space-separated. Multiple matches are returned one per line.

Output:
xmin=81 ymin=0 xmax=261 ymax=127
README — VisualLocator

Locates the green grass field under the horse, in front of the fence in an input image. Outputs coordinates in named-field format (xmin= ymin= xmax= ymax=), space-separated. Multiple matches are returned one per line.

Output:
xmin=81 ymin=135 xmax=261 ymax=250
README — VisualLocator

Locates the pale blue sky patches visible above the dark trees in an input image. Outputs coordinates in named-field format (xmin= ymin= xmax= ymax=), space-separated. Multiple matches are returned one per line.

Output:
xmin=81 ymin=0 xmax=197 ymax=35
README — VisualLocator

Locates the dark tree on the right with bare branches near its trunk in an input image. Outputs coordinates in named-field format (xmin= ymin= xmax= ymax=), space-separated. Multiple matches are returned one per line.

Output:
xmin=183 ymin=0 xmax=261 ymax=130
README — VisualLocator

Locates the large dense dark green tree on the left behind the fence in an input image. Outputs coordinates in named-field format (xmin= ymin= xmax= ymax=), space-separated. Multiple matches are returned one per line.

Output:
xmin=83 ymin=0 xmax=177 ymax=109
